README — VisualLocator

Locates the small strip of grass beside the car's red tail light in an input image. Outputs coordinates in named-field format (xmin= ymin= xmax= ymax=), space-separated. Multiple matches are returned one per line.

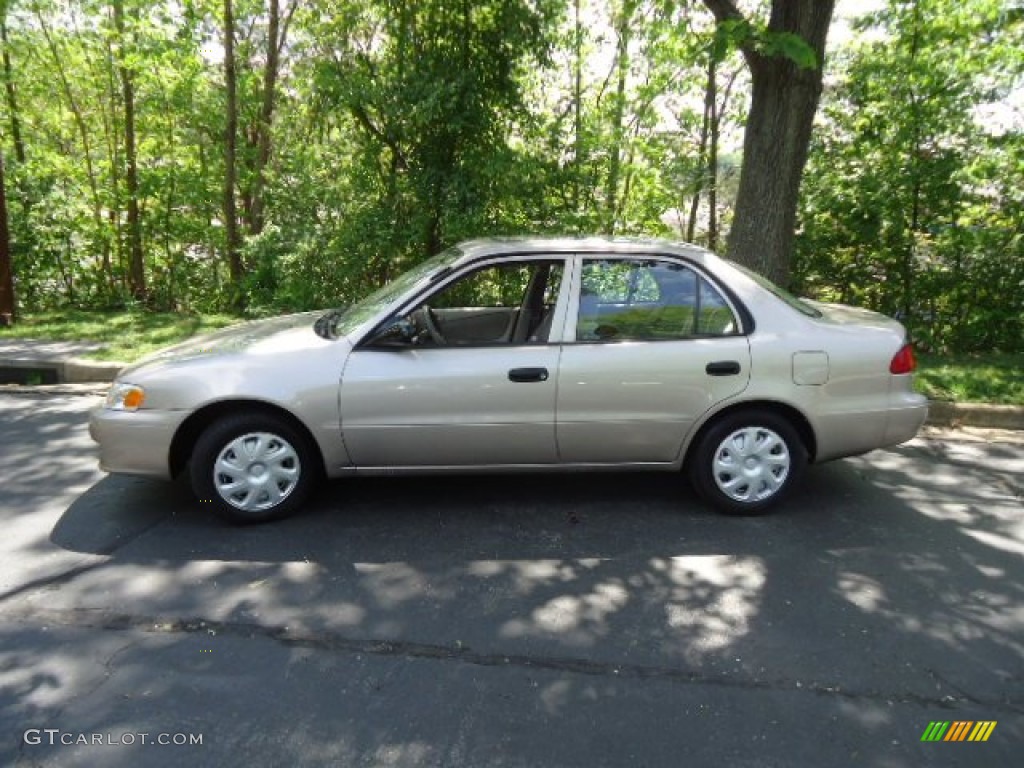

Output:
xmin=915 ymin=352 xmax=1024 ymax=406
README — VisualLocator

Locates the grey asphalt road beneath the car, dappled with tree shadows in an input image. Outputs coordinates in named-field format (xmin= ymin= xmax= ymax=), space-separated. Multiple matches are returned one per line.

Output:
xmin=0 ymin=392 xmax=1024 ymax=768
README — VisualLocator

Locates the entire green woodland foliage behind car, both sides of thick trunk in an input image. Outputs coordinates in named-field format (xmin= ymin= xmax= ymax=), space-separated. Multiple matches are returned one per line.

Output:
xmin=0 ymin=0 xmax=1024 ymax=364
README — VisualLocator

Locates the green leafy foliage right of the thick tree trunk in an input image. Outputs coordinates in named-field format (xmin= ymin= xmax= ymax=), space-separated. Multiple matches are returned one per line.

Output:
xmin=797 ymin=0 xmax=1024 ymax=351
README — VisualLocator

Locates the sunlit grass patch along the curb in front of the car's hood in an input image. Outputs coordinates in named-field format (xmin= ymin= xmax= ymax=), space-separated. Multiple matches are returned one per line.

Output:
xmin=0 ymin=309 xmax=239 ymax=362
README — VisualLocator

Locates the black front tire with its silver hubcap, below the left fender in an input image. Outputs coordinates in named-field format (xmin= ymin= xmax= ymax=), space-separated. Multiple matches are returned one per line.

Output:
xmin=189 ymin=413 xmax=321 ymax=524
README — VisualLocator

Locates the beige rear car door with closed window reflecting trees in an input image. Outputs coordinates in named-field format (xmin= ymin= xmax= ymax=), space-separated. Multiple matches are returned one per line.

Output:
xmin=556 ymin=255 xmax=751 ymax=464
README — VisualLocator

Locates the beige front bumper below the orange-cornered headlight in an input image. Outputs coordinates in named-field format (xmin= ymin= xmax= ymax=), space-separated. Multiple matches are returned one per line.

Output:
xmin=89 ymin=406 xmax=189 ymax=479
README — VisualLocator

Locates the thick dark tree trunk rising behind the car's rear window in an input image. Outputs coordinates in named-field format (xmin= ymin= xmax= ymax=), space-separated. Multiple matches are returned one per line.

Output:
xmin=705 ymin=0 xmax=836 ymax=285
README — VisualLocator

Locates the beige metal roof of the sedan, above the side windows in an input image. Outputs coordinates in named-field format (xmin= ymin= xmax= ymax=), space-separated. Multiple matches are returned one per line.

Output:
xmin=453 ymin=237 xmax=718 ymax=266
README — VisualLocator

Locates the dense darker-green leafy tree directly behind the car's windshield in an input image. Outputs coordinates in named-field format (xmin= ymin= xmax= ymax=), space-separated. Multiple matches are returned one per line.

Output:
xmin=305 ymin=0 xmax=551 ymax=262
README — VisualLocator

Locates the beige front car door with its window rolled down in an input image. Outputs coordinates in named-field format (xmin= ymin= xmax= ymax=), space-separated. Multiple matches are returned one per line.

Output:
xmin=340 ymin=257 xmax=567 ymax=468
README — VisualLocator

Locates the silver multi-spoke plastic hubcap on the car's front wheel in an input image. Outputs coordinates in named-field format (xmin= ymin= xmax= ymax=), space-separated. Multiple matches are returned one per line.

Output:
xmin=213 ymin=432 xmax=302 ymax=512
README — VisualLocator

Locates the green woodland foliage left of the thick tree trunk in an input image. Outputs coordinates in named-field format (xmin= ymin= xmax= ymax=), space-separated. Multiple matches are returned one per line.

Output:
xmin=2 ymin=0 xmax=727 ymax=314
